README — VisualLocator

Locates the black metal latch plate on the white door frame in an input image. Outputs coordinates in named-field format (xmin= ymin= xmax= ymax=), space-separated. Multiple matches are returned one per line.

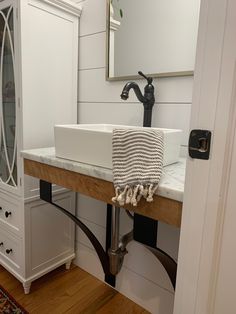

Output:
xmin=188 ymin=130 xmax=211 ymax=160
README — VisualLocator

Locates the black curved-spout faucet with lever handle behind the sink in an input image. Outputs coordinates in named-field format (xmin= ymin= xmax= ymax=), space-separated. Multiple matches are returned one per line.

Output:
xmin=120 ymin=71 xmax=155 ymax=127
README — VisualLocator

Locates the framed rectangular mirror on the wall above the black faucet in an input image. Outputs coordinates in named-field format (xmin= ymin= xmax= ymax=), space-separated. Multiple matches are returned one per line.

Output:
xmin=107 ymin=0 xmax=200 ymax=80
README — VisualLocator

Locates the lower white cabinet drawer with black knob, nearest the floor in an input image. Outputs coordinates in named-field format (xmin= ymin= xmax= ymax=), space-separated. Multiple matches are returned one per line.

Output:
xmin=0 ymin=225 xmax=23 ymax=271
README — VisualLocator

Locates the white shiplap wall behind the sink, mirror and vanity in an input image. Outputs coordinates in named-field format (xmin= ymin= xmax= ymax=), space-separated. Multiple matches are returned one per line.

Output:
xmin=74 ymin=0 xmax=193 ymax=314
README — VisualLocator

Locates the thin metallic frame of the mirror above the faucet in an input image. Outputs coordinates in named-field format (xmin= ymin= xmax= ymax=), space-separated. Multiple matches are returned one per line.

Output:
xmin=106 ymin=0 xmax=194 ymax=81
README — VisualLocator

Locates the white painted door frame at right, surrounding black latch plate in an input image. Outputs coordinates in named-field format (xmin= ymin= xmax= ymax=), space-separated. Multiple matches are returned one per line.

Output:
xmin=174 ymin=0 xmax=236 ymax=314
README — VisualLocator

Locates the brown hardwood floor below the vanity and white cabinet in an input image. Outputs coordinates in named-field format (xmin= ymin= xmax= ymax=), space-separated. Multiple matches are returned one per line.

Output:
xmin=0 ymin=265 xmax=149 ymax=314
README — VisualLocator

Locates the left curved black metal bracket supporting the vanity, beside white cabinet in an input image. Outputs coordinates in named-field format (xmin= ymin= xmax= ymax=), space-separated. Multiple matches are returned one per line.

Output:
xmin=40 ymin=180 xmax=115 ymax=286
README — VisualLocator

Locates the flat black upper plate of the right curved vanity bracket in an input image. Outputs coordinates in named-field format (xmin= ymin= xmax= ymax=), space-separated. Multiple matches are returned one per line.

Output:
xmin=134 ymin=214 xmax=158 ymax=248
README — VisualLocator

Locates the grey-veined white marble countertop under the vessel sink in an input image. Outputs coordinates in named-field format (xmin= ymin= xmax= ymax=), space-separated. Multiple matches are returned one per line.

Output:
xmin=21 ymin=147 xmax=186 ymax=202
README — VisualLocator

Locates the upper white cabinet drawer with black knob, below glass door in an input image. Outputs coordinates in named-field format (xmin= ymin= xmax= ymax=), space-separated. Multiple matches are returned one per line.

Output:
xmin=0 ymin=195 xmax=21 ymax=232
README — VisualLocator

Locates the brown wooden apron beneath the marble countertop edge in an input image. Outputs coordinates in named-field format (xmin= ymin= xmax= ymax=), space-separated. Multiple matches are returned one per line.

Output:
xmin=24 ymin=159 xmax=182 ymax=227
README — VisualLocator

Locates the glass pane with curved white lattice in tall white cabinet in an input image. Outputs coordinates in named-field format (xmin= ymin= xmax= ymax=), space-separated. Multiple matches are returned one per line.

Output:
xmin=0 ymin=6 xmax=17 ymax=187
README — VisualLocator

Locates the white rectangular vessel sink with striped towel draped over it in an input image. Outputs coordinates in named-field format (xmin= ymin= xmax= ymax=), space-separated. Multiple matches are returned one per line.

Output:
xmin=54 ymin=124 xmax=182 ymax=169
